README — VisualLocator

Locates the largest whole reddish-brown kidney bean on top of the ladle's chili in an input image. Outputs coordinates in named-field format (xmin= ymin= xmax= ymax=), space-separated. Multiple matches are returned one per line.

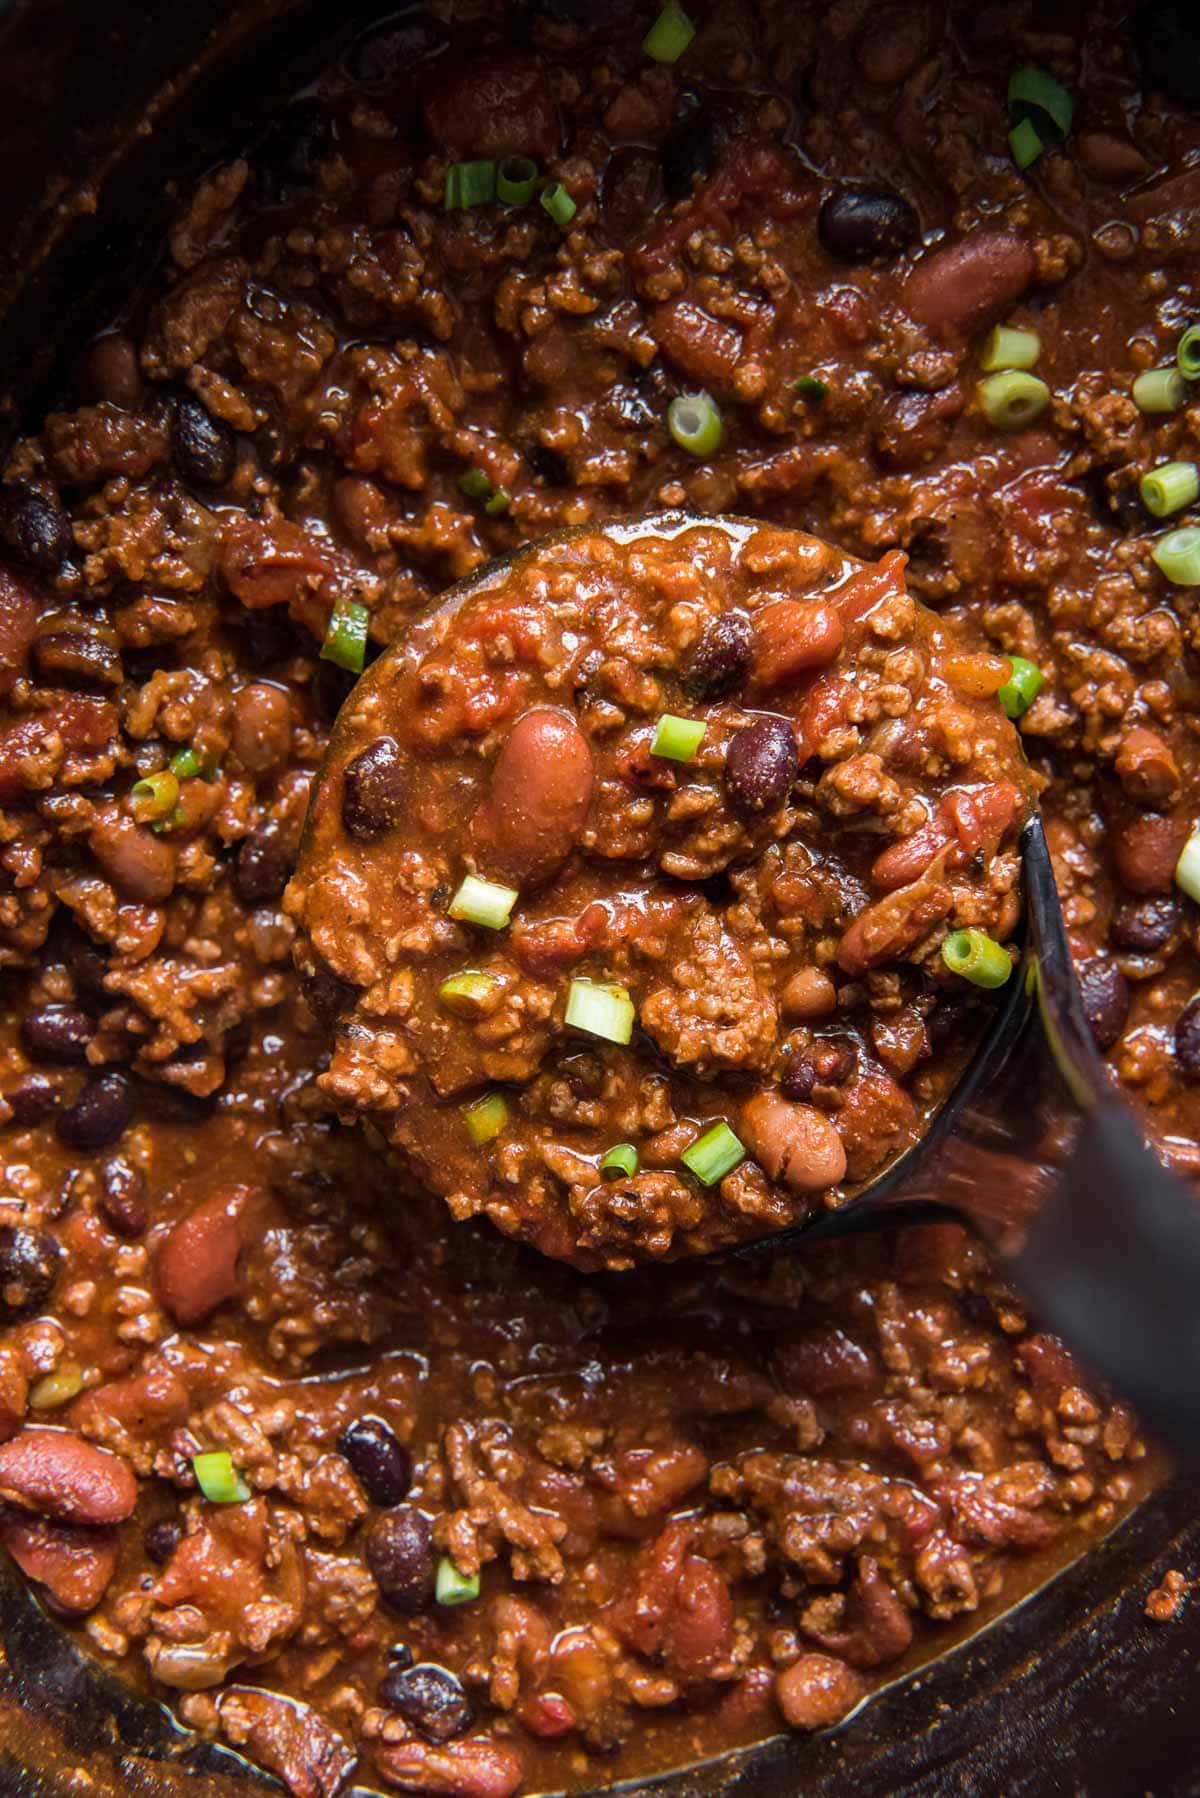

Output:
xmin=471 ymin=707 xmax=594 ymax=888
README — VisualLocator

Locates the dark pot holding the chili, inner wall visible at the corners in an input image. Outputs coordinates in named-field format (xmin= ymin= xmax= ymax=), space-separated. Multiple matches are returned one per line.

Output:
xmin=0 ymin=0 xmax=1200 ymax=1798
